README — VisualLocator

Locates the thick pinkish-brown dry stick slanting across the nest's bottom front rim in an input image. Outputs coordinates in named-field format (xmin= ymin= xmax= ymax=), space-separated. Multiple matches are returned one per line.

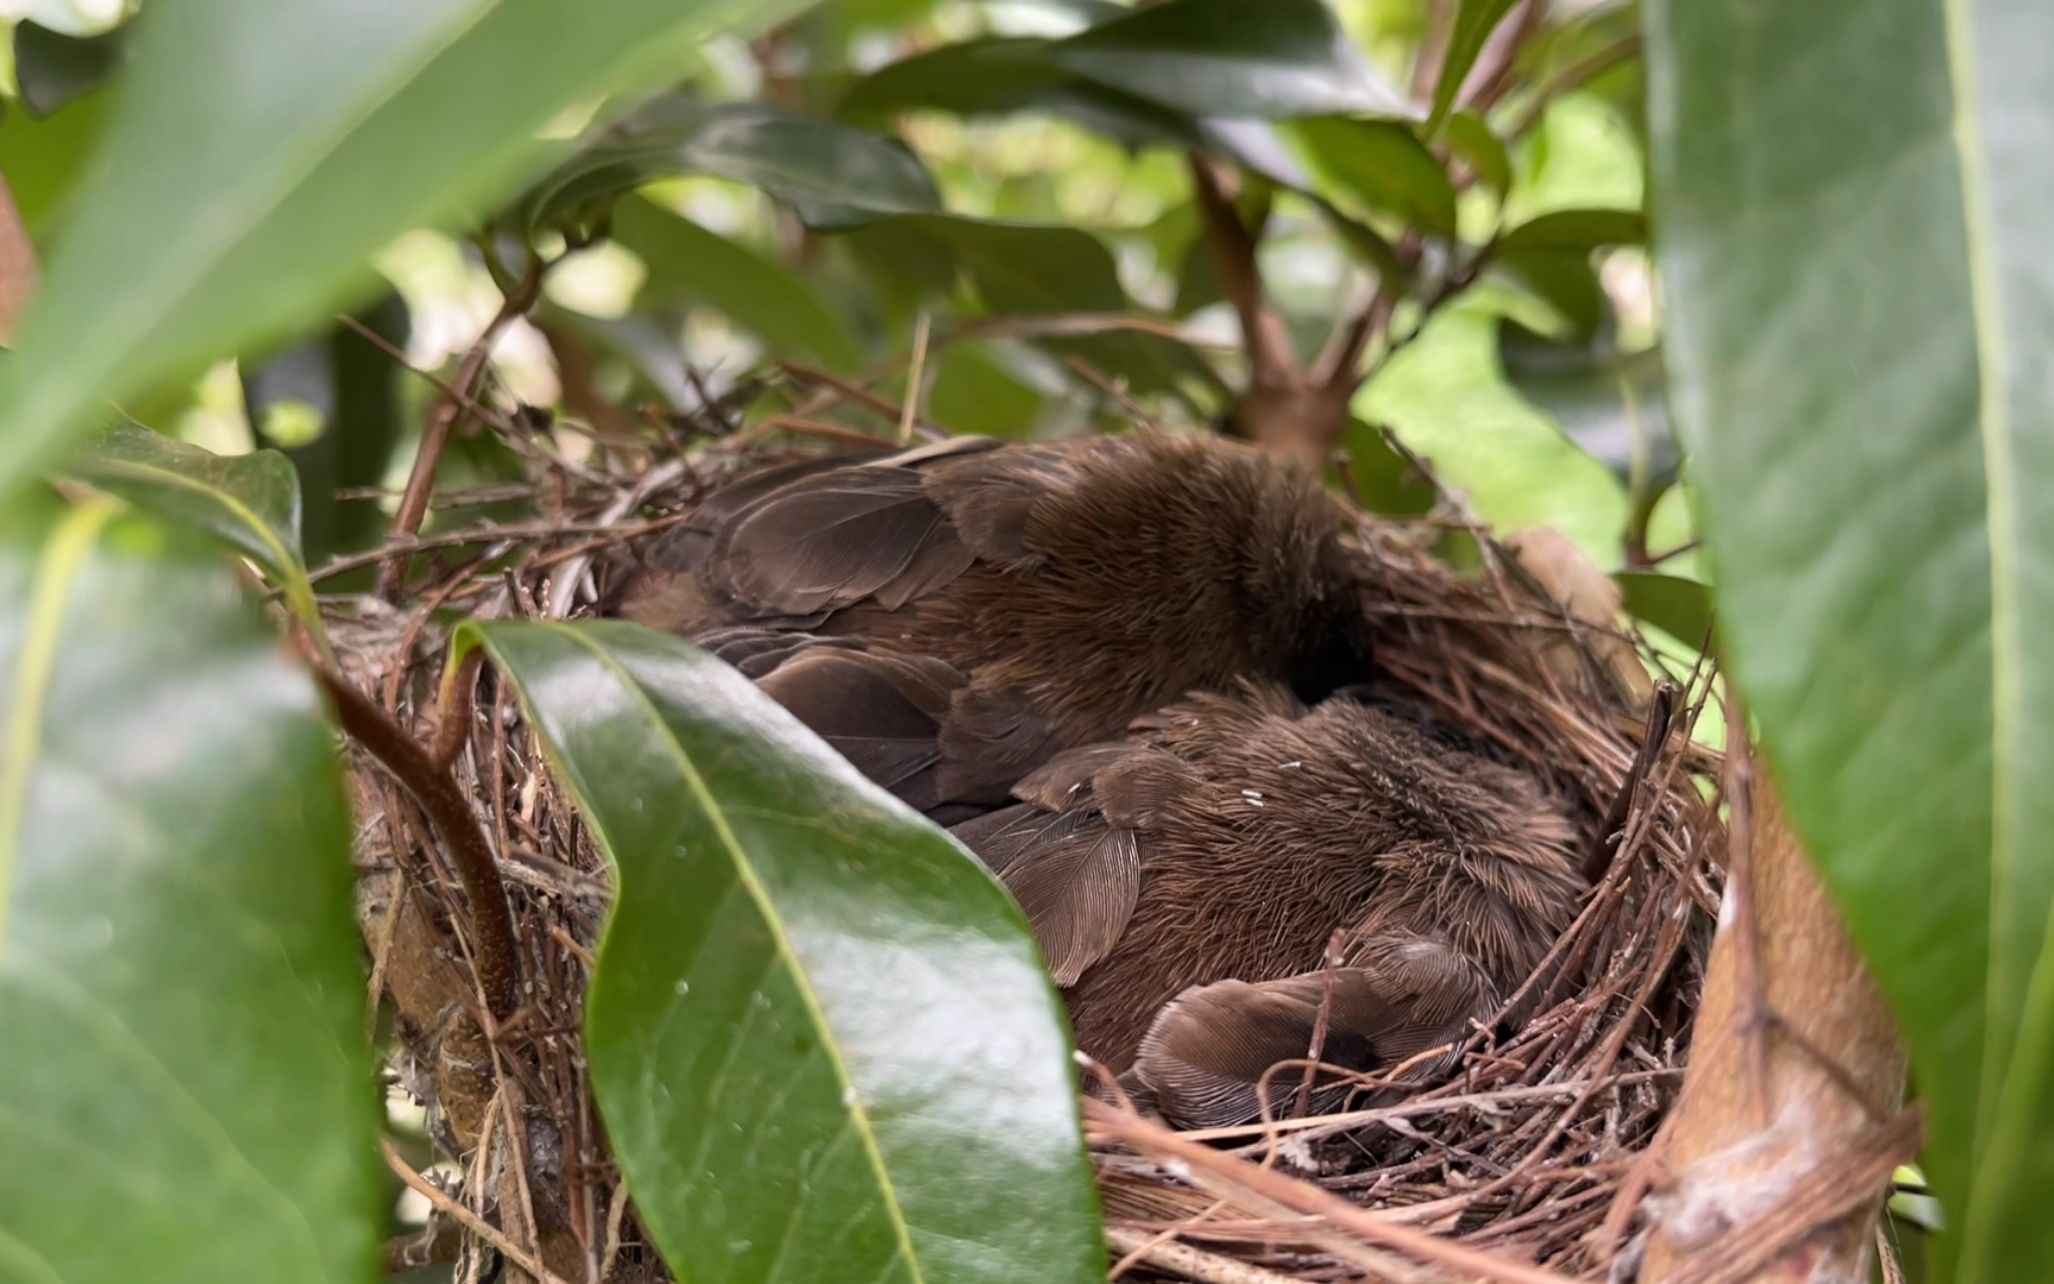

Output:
xmin=1085 ymin=1099 xmax=1569 ymax=1284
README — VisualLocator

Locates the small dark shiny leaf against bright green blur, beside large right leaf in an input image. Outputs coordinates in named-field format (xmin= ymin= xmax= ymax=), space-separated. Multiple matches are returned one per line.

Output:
xmin=1497 ymin=318 xmax=1676 ymax=479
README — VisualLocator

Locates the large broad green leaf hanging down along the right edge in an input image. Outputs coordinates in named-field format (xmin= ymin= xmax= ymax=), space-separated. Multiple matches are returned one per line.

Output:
xmin=1647 ymin=0 xmax=2054 ymax=1284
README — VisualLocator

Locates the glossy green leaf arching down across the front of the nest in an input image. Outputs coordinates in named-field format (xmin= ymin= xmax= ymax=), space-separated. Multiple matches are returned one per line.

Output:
xmin=460 ymin=622 xmax=1105 ymax=1284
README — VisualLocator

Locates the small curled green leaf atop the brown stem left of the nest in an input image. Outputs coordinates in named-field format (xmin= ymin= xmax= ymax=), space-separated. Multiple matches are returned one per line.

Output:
xmin=70 ymin=423 xmax=320 ymax=631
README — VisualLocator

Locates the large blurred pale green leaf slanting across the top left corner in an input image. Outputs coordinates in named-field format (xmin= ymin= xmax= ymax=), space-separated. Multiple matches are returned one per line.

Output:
xmin=0 ymin=0 xmax=817 ymax=501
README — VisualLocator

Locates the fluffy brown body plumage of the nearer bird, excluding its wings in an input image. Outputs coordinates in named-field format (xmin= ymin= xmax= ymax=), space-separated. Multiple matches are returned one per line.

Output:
xmin=961 ymin=684 xmax=1582 ymax=1070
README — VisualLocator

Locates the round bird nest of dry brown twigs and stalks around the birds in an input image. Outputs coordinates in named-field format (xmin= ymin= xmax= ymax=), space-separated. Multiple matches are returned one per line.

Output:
xmin=325 ymin=392 xmax=1723 ymax=1284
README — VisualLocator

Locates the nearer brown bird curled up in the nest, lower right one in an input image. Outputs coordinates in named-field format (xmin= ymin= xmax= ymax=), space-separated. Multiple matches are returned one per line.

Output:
xmin=955 ymin=682 xmax=1584 ymax=1126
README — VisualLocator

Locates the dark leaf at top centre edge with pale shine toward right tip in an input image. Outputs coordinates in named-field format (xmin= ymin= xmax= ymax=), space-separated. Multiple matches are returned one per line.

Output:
xmin=1048 ymin=0 xmax=1421 ymax=117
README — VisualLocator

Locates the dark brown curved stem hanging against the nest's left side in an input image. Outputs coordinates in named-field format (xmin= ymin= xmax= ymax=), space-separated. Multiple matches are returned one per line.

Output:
xmin=310 ymin=659 xmax=520 ymax=1021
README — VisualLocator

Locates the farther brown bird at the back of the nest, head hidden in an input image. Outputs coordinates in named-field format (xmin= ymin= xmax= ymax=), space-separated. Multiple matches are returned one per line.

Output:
xmin=620 ymin=433 xmax=1372 ymax=822
